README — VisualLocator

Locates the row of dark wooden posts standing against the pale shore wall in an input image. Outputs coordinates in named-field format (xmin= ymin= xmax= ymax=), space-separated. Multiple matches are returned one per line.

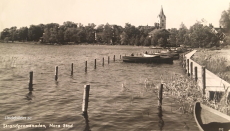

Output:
xmin=182 ymin=54 xmax=206 ymax=96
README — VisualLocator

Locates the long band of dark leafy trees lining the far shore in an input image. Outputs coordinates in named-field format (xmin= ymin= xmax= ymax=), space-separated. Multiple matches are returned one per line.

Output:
xmin=1 ymin=3 xmax=230 ymax=47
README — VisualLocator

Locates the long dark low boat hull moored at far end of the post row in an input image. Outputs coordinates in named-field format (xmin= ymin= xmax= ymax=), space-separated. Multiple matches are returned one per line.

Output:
xmin=122 ymin=56 xmax=173 ymax=63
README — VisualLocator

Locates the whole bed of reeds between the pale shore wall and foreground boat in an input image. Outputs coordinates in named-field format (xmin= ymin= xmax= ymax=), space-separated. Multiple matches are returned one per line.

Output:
xmin=162 ymin=74 xmax=230 ymax=115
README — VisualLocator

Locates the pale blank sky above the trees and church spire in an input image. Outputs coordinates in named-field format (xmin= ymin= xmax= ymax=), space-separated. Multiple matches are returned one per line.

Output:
xmin=0 ymin=0 xmax=230 ymax=31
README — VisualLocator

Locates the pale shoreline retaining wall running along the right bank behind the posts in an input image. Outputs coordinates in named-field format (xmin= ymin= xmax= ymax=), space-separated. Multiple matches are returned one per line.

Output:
xmin=183 ymin=50 xmax=230 ymax=98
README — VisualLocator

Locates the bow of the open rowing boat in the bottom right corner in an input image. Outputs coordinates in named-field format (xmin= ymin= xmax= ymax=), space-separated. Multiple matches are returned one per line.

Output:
xmin=194 ymin=102 xmax=230 ymax=131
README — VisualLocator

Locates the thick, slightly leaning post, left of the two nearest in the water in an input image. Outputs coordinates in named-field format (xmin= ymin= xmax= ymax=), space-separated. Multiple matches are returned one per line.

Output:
xmin=82 ymin=85 xmax=90 ymax=114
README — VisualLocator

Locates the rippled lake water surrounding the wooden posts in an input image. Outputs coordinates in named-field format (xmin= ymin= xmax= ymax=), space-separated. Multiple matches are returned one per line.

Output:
xmin=0 ymin=43 xmax=197 ymax=131
